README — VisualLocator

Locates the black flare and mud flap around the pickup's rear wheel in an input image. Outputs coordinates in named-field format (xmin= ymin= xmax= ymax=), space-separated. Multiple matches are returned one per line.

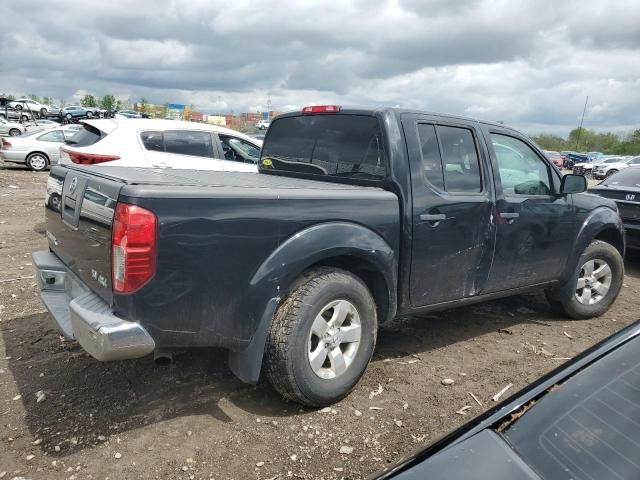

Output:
xmin=229 ymin=222 xmax=398 ymax=383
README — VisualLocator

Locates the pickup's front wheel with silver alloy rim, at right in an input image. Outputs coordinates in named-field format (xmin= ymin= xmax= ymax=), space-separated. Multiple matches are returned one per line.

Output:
xmin=545 ymin=240 xmax=624 ymax=320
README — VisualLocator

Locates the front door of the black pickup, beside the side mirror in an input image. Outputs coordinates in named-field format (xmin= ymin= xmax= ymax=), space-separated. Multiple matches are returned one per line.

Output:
xmin=486 ymin=130 xmax=575 ymax=292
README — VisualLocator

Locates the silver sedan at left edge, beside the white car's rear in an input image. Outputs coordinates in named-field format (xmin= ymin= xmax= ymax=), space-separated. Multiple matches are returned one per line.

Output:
xmin=0 ymin=128 xmax=76 ymax=172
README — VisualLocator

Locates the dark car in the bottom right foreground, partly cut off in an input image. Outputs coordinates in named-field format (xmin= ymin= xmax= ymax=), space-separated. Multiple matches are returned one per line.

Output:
xmin=371 ymin=322 xmax=640 ymax=480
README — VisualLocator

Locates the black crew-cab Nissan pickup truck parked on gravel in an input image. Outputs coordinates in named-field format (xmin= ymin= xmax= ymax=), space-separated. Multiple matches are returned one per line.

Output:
xmin=33 ymin=105 xmax=625 ymax=406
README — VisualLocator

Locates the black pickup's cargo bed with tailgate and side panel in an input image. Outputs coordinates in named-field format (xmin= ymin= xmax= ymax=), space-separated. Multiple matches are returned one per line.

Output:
xmin=47 ymin=166 xmax=400 ymax=350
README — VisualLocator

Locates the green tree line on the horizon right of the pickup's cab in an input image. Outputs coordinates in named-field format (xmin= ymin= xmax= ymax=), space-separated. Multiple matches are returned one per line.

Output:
xmin=531 ymin=127 xmax=640 ymax=155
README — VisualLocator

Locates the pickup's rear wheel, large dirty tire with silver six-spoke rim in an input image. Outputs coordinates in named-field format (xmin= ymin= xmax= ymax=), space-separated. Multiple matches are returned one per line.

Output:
xmin=265 ymin=268 xmax=378 ymax=407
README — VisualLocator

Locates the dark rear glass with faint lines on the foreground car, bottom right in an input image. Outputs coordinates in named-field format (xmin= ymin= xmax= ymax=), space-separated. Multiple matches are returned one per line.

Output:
xmin=504 ymin=339 xmax=640 ymax=480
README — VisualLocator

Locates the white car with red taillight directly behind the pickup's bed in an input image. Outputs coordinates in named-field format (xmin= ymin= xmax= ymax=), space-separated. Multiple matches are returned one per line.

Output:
xmin=60 ymin=119 xmax=262 ymax=172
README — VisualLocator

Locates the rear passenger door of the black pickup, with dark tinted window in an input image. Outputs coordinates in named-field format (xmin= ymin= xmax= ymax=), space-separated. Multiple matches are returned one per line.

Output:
xmin=402 ymin=115 xmax=494 ymax=307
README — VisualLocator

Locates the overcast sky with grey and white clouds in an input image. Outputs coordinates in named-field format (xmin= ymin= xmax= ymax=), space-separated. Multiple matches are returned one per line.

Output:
xmin=0 ymin=0 xmax=640 ymax=135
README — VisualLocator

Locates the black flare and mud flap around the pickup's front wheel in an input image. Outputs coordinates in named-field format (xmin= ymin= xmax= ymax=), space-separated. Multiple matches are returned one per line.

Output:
xmin=553 ymin=207 xmax=624 ymax=300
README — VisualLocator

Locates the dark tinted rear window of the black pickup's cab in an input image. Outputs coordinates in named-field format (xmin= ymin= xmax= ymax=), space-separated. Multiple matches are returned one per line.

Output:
xmin=260 ymin=114 xmax=387 ymax=180
